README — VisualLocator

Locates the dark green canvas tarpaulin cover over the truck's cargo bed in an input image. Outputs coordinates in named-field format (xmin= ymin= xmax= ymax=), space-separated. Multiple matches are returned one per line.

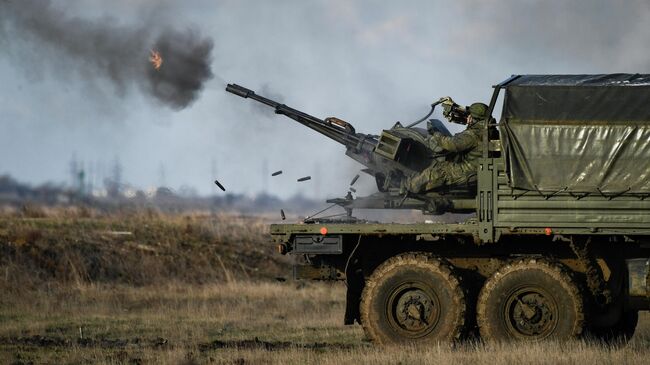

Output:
xmin=499 ymin=74 xmax=650 ymax=194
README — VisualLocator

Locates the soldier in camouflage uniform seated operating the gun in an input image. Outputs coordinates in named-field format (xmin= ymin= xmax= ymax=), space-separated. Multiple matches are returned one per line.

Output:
xmin=402 ymin=99 xmax=488 ymax=194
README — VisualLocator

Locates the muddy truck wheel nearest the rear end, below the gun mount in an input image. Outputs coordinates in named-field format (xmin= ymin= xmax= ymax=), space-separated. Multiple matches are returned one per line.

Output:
xmin=360 ymin=253 xmax=466 ymax=345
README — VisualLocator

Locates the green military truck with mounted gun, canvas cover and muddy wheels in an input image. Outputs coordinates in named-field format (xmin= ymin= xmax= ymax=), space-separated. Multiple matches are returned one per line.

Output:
xmin=228 ymin=74 xmax=650 ymax=344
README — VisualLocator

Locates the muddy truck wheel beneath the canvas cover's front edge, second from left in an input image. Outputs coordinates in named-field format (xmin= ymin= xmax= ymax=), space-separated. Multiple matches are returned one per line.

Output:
xmin=476 ymin=258 xmax=584 ymax=341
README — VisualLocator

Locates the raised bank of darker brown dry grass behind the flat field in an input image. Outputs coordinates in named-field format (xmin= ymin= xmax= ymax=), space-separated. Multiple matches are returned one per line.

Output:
xmin=0 ymin=210 xmax=288 ymax=288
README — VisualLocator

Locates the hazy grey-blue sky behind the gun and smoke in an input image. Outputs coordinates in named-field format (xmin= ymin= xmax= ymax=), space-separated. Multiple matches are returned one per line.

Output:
xmin=0 ymin=0 xmax=650 ymax=198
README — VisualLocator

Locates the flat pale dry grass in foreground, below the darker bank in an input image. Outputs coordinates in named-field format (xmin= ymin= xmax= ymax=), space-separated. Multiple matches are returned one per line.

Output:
xmin=0 ymin=282 xmax=650 ymax=365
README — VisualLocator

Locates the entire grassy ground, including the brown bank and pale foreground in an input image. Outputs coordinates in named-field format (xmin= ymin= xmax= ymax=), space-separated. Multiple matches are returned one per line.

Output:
xmin=0 ymin=215 xmax=650 ymax=365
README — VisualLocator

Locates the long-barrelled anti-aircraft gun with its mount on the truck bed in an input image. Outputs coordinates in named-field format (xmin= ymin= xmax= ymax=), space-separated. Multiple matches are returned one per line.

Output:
xmin=226 ymin=84 xmax=476 ymax=215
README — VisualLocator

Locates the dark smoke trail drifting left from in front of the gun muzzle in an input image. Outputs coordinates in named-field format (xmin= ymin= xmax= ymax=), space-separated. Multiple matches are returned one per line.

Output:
xmin=0 ymin=0 xmax=213 ymax=110
